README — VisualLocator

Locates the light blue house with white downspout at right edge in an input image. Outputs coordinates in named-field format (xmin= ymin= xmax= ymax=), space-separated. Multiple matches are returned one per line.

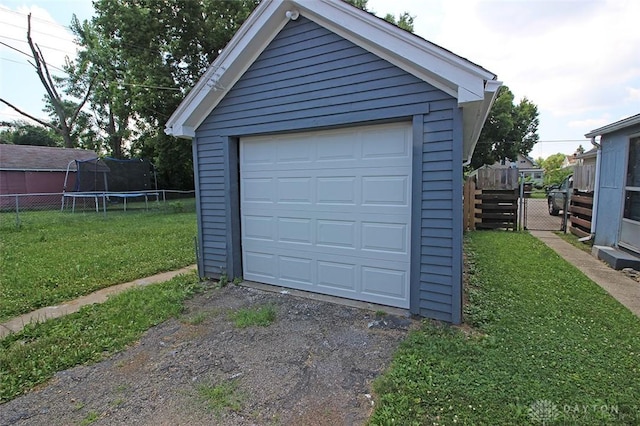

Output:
xmin=585 ymin=114 xmax=640 ymax=269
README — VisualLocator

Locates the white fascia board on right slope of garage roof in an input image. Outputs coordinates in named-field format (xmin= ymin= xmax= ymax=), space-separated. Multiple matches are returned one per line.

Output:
xmin=293 ymin=0 xmax=496 ymax=100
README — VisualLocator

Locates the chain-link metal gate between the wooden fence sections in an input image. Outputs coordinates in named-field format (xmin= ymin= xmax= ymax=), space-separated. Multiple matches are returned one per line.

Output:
xmin=518 ymin=179 xmax=569 ymax=232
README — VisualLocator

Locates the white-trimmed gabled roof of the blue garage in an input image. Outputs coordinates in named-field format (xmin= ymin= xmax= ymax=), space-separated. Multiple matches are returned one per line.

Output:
xmin=165 ymin=0 xmax=501 ymax=161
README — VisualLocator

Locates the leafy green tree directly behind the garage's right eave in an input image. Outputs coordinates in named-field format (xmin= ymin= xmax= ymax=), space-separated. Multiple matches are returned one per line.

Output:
xmin=471 ymin=86 xmax=539 ymax=169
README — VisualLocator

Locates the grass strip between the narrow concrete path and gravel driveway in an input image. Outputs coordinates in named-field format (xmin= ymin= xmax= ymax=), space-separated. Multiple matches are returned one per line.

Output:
xmin=0 ymin=274 xmax=200 ymax=403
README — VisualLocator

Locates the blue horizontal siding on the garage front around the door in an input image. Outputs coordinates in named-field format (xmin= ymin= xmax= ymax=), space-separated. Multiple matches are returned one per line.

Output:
xmin=194 ymin=17 xmax=462 ymax=322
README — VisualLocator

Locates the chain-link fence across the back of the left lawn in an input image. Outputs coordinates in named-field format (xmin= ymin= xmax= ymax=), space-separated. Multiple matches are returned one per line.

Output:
xmin=0 ymin=190 xmax=195 ymax=229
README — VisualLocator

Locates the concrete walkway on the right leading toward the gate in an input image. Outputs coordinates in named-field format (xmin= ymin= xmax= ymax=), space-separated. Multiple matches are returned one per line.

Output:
xmin=529 ymin=231 xmax=640 ymax=317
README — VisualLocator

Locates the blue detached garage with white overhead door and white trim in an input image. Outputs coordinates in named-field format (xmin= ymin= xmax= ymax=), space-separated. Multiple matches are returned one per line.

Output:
xmin=166 ymin=0 xmax=501 ymax=323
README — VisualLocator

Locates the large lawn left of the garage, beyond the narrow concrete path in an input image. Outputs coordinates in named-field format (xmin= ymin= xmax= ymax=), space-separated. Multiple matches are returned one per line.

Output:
xmin=0 ymin=211 xmax=196 ymax=321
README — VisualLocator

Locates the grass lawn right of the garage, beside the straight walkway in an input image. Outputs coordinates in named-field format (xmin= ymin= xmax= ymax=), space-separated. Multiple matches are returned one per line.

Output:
xmin=371 ymin=232 xmax=640 ymax=425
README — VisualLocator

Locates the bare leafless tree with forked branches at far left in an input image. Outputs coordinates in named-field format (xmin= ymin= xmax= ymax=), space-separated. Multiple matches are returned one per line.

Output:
xmin=0 ymin=14 xmax=91 ymax=148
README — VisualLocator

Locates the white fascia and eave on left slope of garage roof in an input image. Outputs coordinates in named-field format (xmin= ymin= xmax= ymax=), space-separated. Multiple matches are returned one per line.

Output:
xmin=165 ymin=0 xmax=289 ymax=137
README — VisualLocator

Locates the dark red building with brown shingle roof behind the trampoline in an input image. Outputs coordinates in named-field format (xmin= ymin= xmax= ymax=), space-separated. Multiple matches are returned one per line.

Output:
xmin=0 ymin=144 xmax=98 ymax=205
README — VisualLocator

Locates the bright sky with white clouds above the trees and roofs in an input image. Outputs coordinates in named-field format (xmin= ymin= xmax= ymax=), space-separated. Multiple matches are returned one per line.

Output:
xmin=0 ymin=0 xmax=640 ymax=158
